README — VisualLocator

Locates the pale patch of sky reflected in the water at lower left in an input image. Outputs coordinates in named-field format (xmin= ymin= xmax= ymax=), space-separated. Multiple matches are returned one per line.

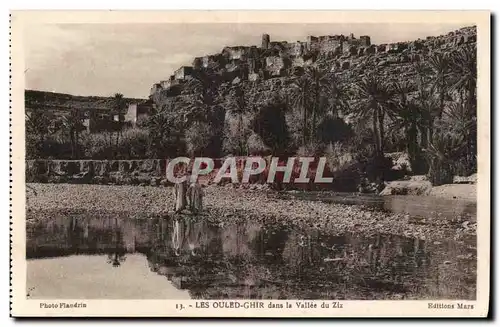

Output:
xmin=26 ymin=253 xmax=190 ymax=299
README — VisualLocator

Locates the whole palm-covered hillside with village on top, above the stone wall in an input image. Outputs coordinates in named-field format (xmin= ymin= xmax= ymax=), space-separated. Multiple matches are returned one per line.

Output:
xmin=26 ymin=26 xmax=477 ymax=190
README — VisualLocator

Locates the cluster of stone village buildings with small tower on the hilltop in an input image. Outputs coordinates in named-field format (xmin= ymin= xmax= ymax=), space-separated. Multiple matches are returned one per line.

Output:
xmin=150 ymin=34 xmax=372 ymax=95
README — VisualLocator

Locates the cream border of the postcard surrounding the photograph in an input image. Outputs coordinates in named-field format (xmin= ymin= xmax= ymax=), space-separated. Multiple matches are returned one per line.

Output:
xmin=10 ymin=10 xmax=491 ymax=317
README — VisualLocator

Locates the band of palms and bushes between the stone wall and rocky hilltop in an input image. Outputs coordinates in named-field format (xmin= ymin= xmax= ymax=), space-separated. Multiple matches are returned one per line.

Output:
xmin=26 ymin=46 xmax=477 ymax=185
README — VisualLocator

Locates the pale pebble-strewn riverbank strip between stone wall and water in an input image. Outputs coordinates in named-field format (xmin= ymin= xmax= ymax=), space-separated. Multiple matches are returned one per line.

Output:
xmin=26 ymin=183 xmax=476 ymax=241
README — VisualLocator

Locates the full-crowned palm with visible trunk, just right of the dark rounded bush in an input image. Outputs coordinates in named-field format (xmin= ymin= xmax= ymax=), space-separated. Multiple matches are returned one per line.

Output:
xmin=355 ymin=75 xmax=393 ymax=157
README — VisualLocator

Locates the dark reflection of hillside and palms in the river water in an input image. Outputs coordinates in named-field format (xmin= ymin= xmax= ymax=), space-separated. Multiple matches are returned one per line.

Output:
xmin=27 ymin=215 xmax=476 ymax=299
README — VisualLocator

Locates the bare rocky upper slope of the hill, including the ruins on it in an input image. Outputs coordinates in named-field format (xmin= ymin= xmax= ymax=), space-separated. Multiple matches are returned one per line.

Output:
xmin=150 ymin=26 xmax=476 ymax=111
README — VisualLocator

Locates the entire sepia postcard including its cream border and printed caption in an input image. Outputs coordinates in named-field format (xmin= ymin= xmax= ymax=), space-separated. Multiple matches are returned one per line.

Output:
xmin=10 ymin=11 xmax=491 ymax=318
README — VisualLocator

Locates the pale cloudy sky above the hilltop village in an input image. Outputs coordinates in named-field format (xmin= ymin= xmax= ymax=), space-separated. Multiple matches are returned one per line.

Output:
xmin=24 ymin=23 xmax=464 ymax=98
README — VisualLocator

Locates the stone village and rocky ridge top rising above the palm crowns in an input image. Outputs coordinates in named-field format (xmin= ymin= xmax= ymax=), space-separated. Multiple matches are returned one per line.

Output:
xmin=150 ymin=27 xmax=476 ymax=104
